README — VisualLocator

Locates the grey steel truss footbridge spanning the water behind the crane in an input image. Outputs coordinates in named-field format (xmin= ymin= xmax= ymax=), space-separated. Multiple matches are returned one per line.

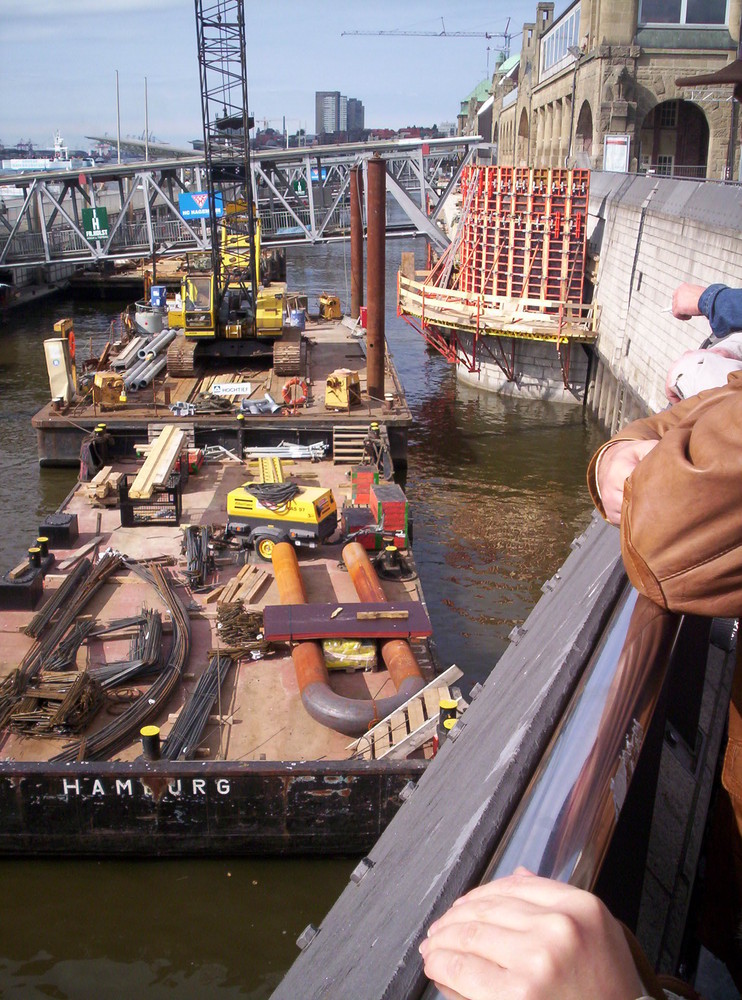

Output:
xmin=0 ymin=136 xmax=492 ymax=268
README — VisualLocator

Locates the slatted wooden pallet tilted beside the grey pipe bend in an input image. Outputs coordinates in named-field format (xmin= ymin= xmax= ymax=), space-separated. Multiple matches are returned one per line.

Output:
xmin=348 ymin=665 xmax=466 ymax=760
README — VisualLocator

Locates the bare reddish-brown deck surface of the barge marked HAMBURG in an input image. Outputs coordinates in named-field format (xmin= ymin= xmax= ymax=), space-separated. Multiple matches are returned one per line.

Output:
xmin=0 ymin=461 xmax=433 ymax=761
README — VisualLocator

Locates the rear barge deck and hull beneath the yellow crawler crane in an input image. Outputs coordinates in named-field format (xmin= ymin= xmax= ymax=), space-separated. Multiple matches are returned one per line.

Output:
xmin=32 ymin=302 xmax=412 ymax=468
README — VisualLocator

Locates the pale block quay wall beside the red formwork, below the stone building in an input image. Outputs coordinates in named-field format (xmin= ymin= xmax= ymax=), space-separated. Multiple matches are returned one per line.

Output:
xmin=587 ymin=172 xmax=742 ymax=430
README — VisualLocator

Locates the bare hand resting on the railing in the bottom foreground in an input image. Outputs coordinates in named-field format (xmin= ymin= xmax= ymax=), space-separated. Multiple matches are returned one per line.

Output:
xmin=420 ymin=868 xmax=644 ymax=1000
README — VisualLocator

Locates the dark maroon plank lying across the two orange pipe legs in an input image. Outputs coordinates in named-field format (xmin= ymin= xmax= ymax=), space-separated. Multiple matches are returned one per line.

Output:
xmin=263 ymin=601 xmax=433 ymax=642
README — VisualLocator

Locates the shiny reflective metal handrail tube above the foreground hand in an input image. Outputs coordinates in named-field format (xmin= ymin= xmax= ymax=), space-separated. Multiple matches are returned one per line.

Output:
xmin=423 ymin=587 xmax=682 ymax=1000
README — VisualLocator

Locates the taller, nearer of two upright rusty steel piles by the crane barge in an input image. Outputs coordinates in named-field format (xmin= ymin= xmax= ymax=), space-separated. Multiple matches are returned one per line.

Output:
xmin=366 ymin=154 xmax=386 ymax=400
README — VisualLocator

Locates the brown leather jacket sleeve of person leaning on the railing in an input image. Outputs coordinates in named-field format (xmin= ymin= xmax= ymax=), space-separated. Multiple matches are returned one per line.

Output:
xmin=587 ymin=372 xmax=742 ymax=617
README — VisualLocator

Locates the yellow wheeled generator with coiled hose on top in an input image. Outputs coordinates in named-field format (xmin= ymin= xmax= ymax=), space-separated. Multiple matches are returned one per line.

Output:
xmin=227 ymin=483 xmax=338 ymax=560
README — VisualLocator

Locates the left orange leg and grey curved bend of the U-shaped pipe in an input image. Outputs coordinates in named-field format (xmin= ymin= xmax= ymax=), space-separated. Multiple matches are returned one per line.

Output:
xmin=273 ymin=542 xmax=425 ymax=736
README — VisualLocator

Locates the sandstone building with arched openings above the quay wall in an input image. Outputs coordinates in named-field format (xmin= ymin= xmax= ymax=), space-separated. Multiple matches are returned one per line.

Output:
xmin=492 ymin=0 xmax=742 ymax=178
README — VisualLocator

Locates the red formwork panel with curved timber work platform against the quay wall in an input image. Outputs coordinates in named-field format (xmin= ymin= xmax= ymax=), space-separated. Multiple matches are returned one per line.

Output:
xmin=398 ymin=166 xmax=597 ymax=385
